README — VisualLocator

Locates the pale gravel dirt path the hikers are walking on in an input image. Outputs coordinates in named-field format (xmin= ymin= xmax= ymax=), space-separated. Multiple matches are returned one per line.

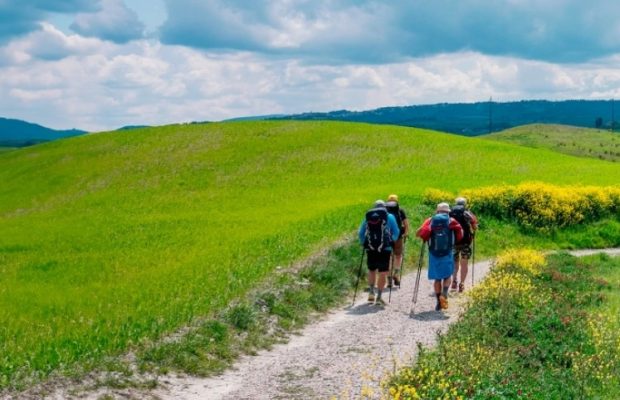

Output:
xmin=26 ymin=249 xmax=620 ymax=400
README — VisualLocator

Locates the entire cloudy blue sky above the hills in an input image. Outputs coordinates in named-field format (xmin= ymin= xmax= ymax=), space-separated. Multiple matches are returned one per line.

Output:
xmin=0 ymin=0 xmax=620 ymax=130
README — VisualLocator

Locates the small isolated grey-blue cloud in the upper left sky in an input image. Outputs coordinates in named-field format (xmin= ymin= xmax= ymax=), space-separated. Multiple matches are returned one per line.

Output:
xmin=70 ymin=0 xmax=144 ymax=43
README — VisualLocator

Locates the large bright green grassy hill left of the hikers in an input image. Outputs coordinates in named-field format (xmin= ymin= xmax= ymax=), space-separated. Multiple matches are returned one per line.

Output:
xmin=0 ymin=122 xmax=620 ymax=387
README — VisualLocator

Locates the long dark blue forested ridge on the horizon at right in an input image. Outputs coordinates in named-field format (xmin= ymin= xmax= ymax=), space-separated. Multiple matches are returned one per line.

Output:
xmin=271 ymin=100 xmax=620 ymax=136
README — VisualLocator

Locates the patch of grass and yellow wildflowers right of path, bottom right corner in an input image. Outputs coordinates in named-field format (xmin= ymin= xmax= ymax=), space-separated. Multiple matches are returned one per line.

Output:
xmin=386 ymin=251 xmax=620 ymax=399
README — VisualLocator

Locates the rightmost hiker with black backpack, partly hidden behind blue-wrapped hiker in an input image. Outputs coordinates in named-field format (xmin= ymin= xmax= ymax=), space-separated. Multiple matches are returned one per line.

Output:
xmin=450 ymin=197 xmax=478 ymax=293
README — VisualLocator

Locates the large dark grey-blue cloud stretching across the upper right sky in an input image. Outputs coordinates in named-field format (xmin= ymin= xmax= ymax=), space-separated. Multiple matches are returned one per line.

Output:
xmin=161 ymin=0 xmax=620 ymax=63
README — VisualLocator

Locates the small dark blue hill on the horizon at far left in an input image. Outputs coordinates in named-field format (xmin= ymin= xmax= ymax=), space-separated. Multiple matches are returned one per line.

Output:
xmin=0 ymin=117 xmax=86 ymax=147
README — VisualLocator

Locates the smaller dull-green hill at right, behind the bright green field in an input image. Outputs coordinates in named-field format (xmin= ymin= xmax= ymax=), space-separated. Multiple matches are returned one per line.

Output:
xmin=483 ymin=124 xmax=620 ymax=161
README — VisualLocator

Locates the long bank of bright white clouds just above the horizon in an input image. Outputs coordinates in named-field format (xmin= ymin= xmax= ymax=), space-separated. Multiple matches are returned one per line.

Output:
xmin=0 ymin=38 xmax=620 ymax=130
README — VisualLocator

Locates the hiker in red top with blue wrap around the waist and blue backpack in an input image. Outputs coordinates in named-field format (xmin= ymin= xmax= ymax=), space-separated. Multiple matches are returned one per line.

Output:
xmin=416 ymin=203 xmax=463 ymax=311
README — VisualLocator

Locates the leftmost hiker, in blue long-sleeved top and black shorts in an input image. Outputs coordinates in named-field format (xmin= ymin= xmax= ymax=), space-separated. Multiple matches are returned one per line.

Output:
xmin=359 ymin=200 xmax=400 ymax=305
